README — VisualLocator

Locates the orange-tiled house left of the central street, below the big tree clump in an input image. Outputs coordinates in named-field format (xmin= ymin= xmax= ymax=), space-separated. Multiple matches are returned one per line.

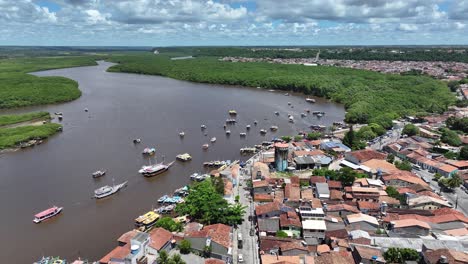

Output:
xmin=185 ymin=224 xmax=232 ymax=261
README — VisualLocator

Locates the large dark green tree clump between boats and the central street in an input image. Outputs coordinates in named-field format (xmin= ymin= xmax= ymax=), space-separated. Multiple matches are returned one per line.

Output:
xmin=176 ymin=179 xmax=245 ymax=225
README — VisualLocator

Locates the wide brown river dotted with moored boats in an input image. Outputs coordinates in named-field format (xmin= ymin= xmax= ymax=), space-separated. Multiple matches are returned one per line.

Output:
xmin=0 ymin=62 xmax=344 ymax=263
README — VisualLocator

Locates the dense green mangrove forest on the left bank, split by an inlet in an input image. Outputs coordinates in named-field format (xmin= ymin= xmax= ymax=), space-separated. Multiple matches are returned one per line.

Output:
xmin=0 ymin=56 xmax=96 ymax=109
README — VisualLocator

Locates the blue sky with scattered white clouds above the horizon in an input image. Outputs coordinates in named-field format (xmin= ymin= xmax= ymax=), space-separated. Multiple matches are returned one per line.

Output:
xmin=0 ymin=0 xmax=468 ymax=46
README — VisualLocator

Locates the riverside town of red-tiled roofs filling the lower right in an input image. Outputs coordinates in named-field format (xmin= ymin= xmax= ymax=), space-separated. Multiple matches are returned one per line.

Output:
xmin=38 ymin=99 xmax=468 ymax=264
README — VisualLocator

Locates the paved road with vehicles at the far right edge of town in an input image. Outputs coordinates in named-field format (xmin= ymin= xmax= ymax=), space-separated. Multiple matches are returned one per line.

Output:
xmin=413 ymin=170 xmax=468 ymax=215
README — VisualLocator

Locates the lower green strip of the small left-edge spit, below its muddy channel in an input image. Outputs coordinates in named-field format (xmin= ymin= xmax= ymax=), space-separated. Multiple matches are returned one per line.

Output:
xmin=0 ymin=123 xmax=61 ymax=149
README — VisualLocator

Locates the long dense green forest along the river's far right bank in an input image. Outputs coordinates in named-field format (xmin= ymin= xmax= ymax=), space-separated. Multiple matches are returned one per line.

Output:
xmin=109 ymin=53 xmax=455 ymax=127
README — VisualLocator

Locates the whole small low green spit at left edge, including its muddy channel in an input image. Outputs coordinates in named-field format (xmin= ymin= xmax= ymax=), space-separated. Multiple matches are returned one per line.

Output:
xmin=0 ymin=112 xmax=62 ymax=152
